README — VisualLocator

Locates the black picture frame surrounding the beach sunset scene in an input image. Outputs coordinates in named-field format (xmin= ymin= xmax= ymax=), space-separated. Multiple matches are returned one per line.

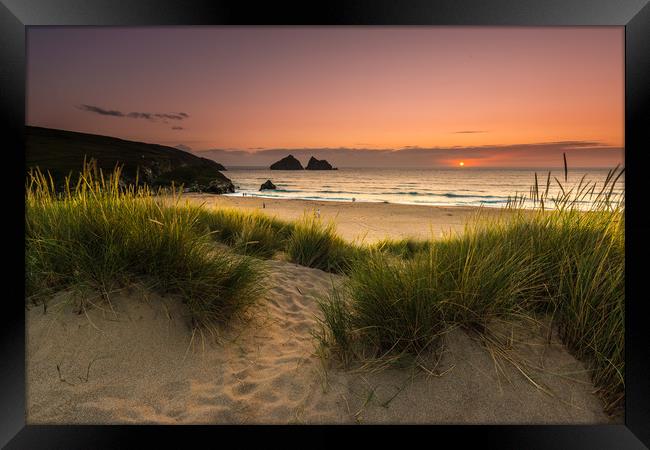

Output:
xmin=0 ymin=0 xmax=650 ymax=449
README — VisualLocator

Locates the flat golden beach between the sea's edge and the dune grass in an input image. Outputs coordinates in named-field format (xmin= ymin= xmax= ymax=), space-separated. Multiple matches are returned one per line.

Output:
xmin=173 ymin=194 xmax=502 ymax=243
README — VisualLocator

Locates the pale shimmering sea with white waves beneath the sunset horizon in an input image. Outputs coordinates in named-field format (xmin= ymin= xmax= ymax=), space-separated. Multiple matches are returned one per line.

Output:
xmin=225 ymin=167 xmax=625 ymax=208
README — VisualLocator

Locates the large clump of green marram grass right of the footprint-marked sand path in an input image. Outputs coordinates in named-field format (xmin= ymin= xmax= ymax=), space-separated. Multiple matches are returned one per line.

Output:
xmin=319 ymin=169 xmax=625 ymax=412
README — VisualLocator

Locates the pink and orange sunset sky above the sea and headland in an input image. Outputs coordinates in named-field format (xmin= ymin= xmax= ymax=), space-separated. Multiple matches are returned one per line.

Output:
xmin=27 ymin=27 xmax=624 ymax=167
